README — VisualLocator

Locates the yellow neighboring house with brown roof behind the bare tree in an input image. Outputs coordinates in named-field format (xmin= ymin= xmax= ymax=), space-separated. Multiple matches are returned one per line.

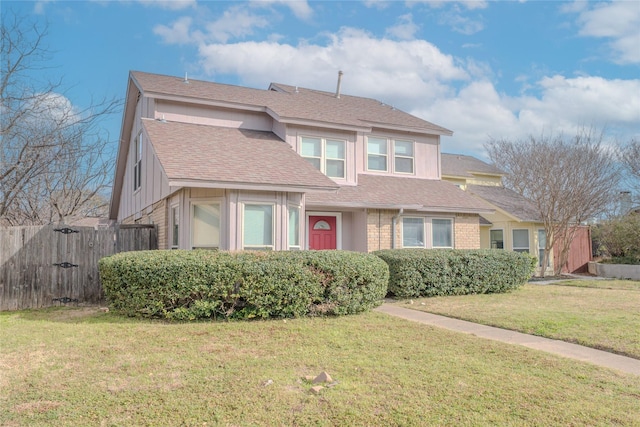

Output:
xmin=442 ymin=153 xmax=591 ymax=274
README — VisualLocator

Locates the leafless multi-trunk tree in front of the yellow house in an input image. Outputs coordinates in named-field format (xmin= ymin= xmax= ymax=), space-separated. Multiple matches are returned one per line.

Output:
xmin=485 ymin=129 xmax=620 ymax=276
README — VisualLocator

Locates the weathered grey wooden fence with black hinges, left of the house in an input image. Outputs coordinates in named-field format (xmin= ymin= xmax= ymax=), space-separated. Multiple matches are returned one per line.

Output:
xmin=0 ymin=225 xmax=158 ymax=311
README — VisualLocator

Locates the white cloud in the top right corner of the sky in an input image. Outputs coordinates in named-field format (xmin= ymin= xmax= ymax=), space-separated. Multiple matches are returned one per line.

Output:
xmin=565 ymin=1 xmax=640 ymax=64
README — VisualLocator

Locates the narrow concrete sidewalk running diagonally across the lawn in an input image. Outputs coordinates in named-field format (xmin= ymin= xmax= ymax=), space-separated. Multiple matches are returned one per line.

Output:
xmin=375 ymin=303 xmax=640 ymax=375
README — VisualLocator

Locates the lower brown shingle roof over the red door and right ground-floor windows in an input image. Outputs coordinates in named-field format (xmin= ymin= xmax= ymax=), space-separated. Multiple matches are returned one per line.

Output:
xmin=306 ymin=174 xmax=494 ymax=213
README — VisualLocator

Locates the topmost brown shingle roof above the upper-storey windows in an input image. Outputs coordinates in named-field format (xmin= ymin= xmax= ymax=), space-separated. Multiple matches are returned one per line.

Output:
xmin=131 ymin=71 xmax=452 ymax=135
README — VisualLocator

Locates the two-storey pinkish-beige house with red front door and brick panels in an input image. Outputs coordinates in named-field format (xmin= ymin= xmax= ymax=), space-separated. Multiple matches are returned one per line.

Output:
xmin=110 ymin=72 xmax=493 ymax=252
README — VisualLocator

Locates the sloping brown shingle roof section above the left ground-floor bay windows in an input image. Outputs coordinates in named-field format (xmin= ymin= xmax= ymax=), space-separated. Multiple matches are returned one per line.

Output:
xmin=142 ymin=119 xmax=338 ymax=190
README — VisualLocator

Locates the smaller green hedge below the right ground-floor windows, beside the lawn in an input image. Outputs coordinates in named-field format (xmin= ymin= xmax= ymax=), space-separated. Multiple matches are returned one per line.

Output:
xmin=374 ymin=249 xmax=535 ymax=298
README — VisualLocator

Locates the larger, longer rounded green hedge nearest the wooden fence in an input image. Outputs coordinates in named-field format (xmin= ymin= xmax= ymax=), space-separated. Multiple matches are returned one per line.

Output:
xmin=98 ymin=250 xmax=389 ymax=320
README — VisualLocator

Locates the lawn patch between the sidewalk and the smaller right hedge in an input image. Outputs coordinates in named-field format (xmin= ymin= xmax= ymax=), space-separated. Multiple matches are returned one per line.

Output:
xmin=401 ymin=280 xmax=640 ymax=359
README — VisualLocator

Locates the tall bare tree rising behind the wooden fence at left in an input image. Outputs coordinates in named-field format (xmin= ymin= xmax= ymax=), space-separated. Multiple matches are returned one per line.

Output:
xmin=0 ymin=11 xmax=118 ymax=225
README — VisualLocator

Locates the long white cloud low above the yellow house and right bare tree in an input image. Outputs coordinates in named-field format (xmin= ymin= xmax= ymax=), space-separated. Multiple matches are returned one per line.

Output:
xmin=422 ymin=75 xmax=640 ymax=156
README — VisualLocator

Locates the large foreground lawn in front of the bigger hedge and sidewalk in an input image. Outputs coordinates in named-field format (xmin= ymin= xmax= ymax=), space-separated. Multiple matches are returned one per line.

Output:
xmin=0 ymin=308 xmax=640 ymax=426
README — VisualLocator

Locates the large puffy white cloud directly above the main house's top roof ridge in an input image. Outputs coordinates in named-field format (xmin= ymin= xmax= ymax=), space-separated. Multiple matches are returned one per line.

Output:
xmin=200 ymin=28 xmax=469 ymax=109
